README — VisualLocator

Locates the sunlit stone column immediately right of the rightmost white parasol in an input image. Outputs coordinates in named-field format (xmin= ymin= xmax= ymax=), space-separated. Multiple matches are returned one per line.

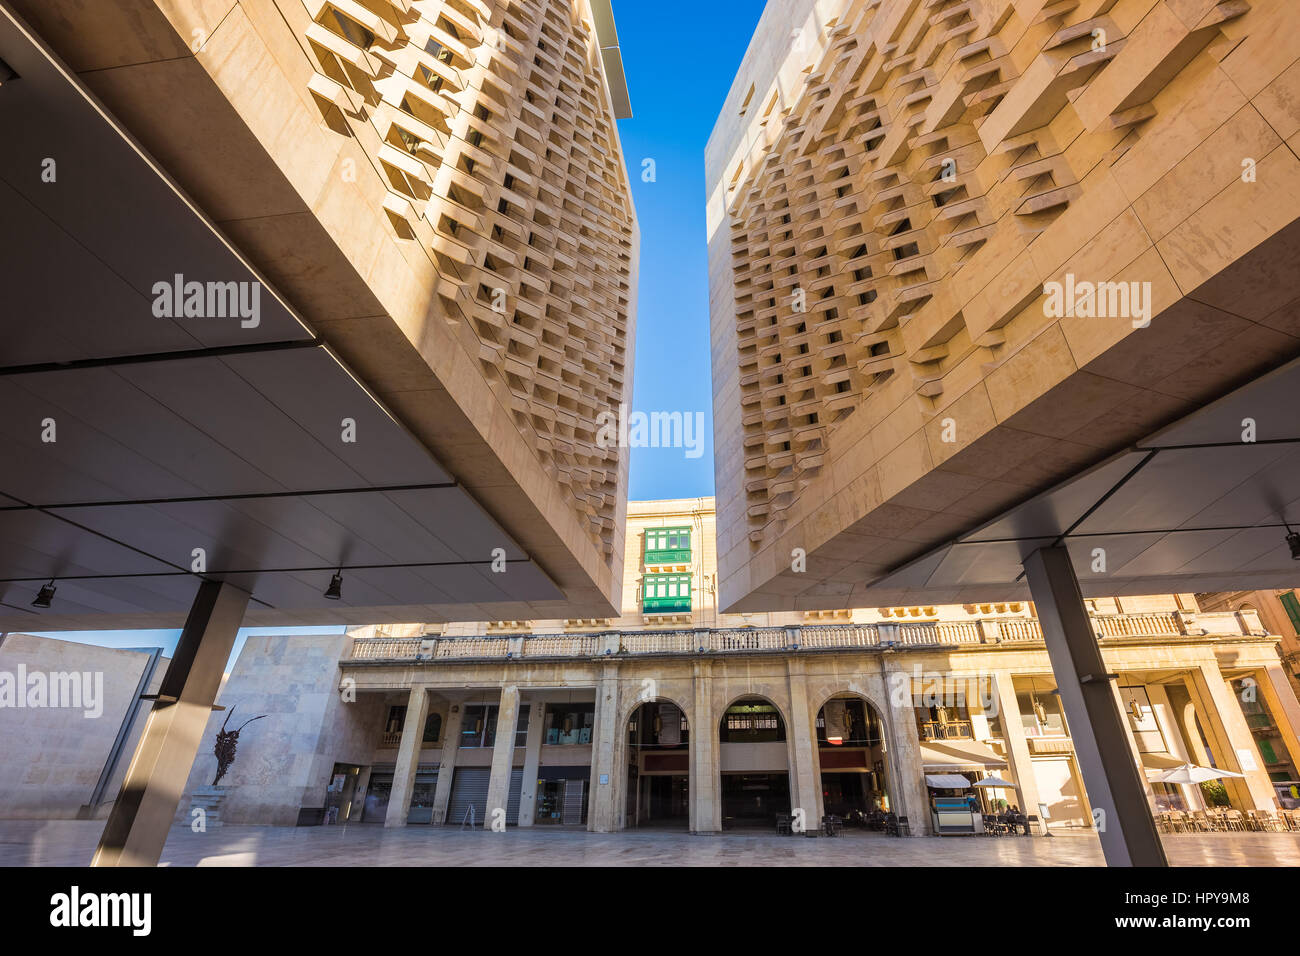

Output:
xmin=1187 ymin=661 xmax=1277 ymax=810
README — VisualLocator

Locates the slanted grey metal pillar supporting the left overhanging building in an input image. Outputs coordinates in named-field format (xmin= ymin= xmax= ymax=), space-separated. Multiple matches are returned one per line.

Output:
xmin=91 ymin=580 xmax=248 ymax=866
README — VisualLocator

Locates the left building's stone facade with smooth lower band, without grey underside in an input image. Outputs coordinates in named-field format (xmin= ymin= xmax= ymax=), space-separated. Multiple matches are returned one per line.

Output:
xmin=13 ymin=0 xmax=638 ymax=620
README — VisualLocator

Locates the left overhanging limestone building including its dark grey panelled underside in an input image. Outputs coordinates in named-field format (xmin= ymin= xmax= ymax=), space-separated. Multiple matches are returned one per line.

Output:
xmin=0 ymin=0 xmax=638 ymax=628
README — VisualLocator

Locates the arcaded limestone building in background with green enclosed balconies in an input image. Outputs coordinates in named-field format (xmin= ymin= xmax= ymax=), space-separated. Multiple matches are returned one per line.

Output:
xmin=182 ymin=498 xmax=1300 ymax=834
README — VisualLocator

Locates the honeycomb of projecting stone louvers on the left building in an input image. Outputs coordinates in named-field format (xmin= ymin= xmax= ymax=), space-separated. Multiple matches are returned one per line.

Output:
xmin=303 ymin=0 xmax=636 ymax=558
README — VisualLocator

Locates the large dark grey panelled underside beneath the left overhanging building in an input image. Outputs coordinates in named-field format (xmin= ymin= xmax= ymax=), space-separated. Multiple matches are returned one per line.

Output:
xmin=0 ymin=12 xmax=564 ymax=630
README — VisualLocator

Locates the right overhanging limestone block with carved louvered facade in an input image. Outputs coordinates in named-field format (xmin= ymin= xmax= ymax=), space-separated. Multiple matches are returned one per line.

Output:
xmin=706 ymin=0 xmax=1300 ymax=610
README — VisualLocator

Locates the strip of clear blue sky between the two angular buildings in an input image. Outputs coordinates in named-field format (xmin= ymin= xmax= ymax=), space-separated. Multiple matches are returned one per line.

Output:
xmin=614 ymin=0 xmax=764 ymax=499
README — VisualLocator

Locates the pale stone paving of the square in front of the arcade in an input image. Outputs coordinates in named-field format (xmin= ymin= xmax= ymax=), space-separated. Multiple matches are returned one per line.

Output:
xmin=0 ymin=819 xmax=1300 ymax=866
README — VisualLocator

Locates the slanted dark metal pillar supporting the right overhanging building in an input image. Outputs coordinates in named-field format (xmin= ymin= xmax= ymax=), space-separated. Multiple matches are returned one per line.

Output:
xmin=1024 ymin=545 xmax=1169 ymax=866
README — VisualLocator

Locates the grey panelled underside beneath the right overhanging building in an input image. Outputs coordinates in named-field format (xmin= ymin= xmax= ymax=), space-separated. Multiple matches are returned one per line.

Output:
xmin=852 ymin=359 xmax=1300 ymax=605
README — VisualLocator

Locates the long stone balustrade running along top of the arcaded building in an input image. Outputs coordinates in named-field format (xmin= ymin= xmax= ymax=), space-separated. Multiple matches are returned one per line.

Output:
xmin=347 ymin=611 xmax=1266 ymax=662
